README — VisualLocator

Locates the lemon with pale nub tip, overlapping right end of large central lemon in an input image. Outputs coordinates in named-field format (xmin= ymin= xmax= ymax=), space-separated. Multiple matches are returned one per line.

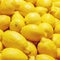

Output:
xmin=39 ymin=23 xmax=53 ymax=38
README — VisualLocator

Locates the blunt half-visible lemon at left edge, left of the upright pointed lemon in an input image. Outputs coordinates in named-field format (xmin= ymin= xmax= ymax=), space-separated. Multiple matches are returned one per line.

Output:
xmin=0 ymin=15 xmax=10 ymax=30
